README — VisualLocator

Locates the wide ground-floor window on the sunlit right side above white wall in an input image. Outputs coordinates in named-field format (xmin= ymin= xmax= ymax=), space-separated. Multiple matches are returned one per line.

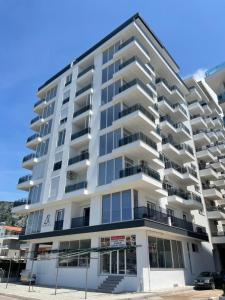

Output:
xmin=148 ymin=237 xmax=184 ymax=269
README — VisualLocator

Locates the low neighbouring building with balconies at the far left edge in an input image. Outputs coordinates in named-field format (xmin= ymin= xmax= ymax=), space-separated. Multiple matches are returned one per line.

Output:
xmin=0 ymin=225 xmax=25 ymax=260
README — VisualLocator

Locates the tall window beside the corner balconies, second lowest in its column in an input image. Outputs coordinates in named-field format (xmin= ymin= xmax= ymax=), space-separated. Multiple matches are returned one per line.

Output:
xmin=98 ymin=157 xmax=122 ymax=185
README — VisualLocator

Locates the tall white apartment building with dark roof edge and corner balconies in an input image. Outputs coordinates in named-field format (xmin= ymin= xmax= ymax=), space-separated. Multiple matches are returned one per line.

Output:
xmin=11 ymin=14 xmax=214 ymax=292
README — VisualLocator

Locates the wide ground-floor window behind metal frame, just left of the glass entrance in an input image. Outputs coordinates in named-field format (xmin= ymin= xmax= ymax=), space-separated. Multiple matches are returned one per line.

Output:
xmin=58 ymin=239 xmax=91 ymax=267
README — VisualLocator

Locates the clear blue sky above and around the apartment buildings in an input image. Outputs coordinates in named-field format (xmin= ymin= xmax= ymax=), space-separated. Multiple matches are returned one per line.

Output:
xmin=0 ymin=0 xmax=225 ymax=200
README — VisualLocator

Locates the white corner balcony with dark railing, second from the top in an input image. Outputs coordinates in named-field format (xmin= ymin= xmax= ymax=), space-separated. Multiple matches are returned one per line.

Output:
xmin=113 ymin=56 xmax=153 ymax=84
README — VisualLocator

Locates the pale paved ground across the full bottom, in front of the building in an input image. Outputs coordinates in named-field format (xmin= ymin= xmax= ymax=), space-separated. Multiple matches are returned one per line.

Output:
xmin=0 ymin=283 xmax=222 ymax=300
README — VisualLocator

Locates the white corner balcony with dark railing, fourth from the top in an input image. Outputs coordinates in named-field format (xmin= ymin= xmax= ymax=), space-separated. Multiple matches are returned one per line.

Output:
xmin=113 ymin=104 xmax=156 ymax=135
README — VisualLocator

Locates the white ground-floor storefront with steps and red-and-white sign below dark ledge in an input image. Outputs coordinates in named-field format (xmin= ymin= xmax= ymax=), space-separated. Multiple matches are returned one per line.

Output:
xmin=23 ymin=227 xmax=214 ymax=292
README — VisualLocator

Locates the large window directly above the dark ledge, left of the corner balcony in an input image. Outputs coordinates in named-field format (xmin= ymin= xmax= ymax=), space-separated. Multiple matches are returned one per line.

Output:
xmin=102 ymin=190 xmax=132 ymax=224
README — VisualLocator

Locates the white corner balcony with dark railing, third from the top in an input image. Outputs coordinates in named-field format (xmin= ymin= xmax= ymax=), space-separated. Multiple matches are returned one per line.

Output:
xmin=113 ymin=79 xmax=156 ymax=108
